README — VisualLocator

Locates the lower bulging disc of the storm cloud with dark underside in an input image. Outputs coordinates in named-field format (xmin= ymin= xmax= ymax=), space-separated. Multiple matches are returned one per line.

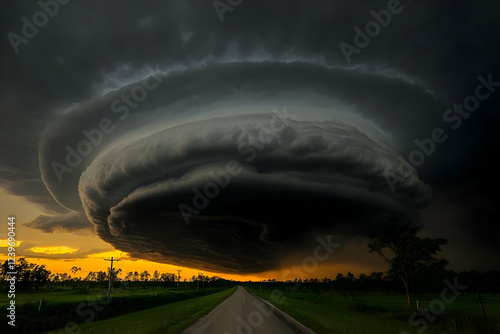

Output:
xmin=75 ymin=115 xmax=431 ymax=273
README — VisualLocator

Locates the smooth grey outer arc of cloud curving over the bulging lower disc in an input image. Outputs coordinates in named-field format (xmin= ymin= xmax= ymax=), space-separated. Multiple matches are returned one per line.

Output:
xmin=39 ymin=62 xmax=441 ymax=210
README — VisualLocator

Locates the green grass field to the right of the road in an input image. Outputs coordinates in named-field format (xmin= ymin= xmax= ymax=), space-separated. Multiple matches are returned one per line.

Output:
xmin=246 ymin=286 xmax=500 ymax=334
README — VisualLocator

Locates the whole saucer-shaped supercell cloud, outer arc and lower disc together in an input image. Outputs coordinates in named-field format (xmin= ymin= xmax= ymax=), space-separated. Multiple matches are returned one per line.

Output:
xmin=39 ymin=62 xmax=432 ymax=272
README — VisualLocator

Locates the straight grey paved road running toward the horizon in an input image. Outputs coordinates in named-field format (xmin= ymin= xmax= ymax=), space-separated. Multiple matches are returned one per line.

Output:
xmin=184 ymin=286 xmax=314 ymax=334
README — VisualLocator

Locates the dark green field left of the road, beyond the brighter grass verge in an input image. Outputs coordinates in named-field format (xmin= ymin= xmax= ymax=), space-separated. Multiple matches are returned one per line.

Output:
xmin=0 ymin=287 xmax=234 ymax=334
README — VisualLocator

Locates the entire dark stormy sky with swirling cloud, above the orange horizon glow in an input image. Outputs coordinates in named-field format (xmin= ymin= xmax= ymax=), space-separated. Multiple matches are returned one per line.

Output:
xmin=0 ymin=0 xmax=500 ymax=273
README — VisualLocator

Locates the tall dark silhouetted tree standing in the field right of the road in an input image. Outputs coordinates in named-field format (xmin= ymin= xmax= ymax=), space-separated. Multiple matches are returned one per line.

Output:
xmin=368 ymin=219 xmax=448 ymax=312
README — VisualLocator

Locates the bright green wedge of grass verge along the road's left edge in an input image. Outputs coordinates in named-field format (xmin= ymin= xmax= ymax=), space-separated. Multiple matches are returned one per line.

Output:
xmin=52 ymin=287 xmax=236 ymax=334
